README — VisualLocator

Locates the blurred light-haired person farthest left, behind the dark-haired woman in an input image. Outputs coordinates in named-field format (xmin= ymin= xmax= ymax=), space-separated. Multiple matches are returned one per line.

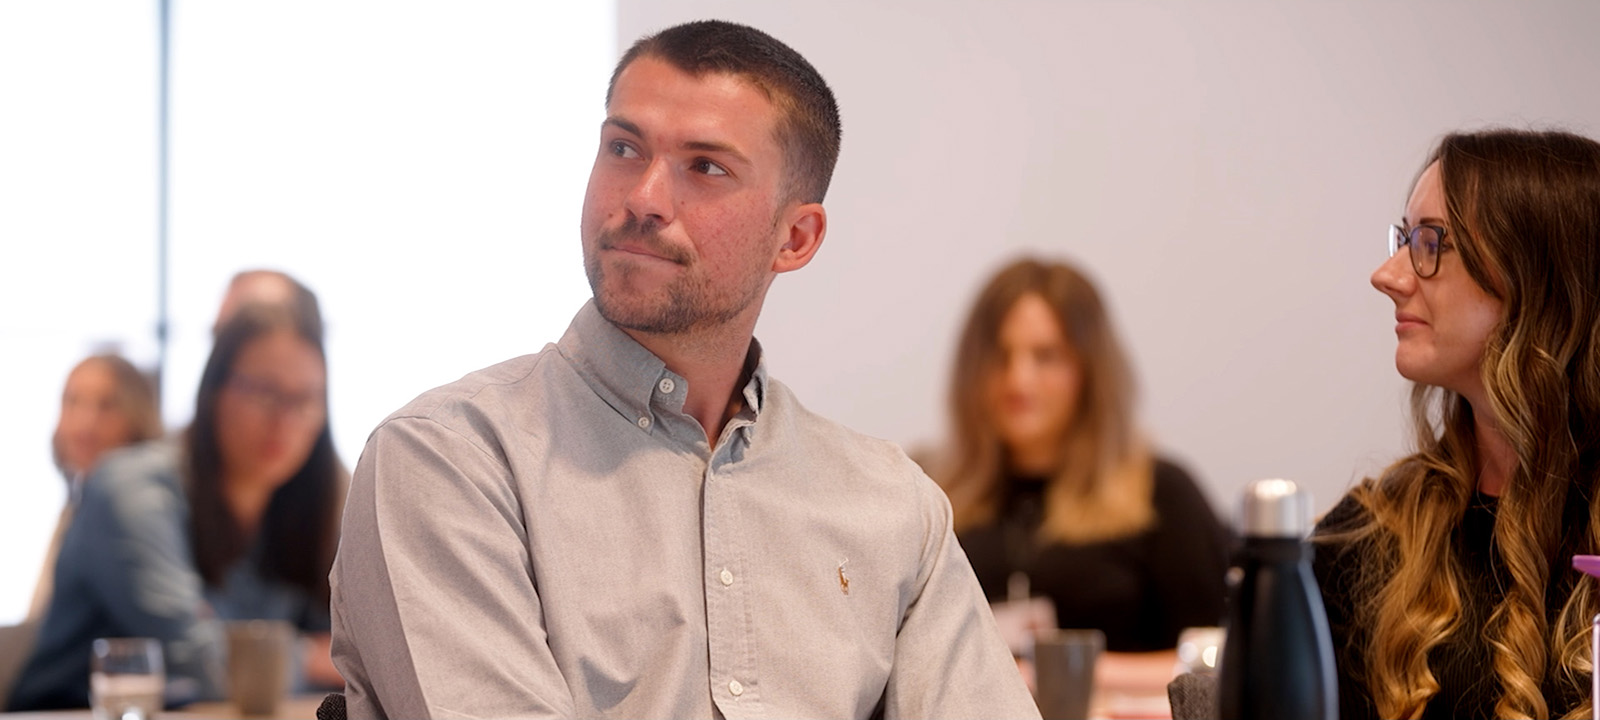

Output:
xmin=27 ymin=354 xmax=162 ymax=619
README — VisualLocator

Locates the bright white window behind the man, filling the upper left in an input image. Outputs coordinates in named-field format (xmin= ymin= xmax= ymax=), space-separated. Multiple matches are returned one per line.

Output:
xmin=0 ymin=0 xmax=616 ymax=622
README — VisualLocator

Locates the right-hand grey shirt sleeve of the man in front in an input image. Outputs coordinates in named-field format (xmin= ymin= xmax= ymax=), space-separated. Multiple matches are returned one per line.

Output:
xmin=883 ymin=474 xmax=1038 ymax=720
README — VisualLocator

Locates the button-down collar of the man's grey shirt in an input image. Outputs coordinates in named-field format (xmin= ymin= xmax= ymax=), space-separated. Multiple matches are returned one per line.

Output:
xmin=555 ymin=299 xmax=766 ymax=432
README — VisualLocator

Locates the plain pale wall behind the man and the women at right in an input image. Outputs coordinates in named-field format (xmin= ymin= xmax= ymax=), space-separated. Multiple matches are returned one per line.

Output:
xmin=618 ymin=0 xmax=1600 ymax=514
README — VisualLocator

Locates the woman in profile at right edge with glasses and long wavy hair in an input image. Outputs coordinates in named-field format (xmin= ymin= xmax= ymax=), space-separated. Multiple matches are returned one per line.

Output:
xmin=1315 ymin=130 xmax=1600 ymax=718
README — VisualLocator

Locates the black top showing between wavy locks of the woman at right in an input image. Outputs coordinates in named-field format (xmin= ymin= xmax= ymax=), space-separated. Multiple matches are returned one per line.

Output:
xmin=1312 ymin=493 xmax=1590 ymax=720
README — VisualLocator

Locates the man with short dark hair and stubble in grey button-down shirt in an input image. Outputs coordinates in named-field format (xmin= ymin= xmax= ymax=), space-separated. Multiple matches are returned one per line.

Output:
xmin=333 ymin=22 xmax=1038 ymax=718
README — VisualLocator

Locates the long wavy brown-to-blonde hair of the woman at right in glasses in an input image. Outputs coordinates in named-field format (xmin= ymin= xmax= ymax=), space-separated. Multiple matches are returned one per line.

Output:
xmin=1328 ymin=130 xmax=1600 ymax=718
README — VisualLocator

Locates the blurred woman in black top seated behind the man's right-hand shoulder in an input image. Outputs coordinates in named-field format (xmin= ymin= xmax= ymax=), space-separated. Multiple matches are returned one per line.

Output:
xmin=928 ymin=258 xmax=1227 ymax=686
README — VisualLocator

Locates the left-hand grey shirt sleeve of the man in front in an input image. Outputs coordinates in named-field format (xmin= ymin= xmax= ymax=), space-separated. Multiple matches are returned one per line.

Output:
xmin=331 ymin=418 xmax=574 ymax=718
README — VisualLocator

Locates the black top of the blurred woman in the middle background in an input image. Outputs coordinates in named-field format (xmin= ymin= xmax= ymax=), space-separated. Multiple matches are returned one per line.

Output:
xmin=957 ymin=459 xmax=1229 ymax=653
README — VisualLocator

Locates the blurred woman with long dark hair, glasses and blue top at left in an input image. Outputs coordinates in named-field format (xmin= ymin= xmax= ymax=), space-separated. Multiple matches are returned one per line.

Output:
xmin=10 ymin=296 xmax=347 ymax=710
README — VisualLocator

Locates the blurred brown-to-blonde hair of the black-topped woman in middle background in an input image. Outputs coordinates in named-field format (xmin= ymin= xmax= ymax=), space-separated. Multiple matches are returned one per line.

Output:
xmin=933 ymin=258 xmax=1155 ymax=544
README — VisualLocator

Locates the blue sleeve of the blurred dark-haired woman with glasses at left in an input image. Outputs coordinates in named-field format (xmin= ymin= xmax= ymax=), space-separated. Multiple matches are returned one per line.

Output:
xmin=75 ymin=464 xmax=222 ymax=699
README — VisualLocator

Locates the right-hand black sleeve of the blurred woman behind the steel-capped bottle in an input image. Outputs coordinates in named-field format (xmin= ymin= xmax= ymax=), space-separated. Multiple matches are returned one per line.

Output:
xmin=1147 ymin=461 xmax=1229 ymax=648
